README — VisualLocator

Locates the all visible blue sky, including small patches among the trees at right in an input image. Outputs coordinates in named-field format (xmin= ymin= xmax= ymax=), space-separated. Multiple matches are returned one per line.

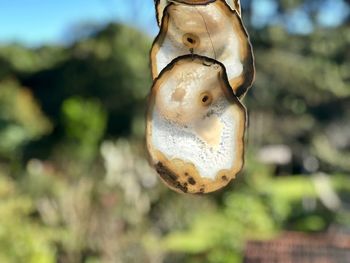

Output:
xmin=0 ymin=0 xmax=349 ymax=46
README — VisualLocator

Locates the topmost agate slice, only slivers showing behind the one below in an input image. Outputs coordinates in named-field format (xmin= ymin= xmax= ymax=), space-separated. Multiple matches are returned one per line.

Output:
xmin=154 ymin=0 xmax=241 ymax=25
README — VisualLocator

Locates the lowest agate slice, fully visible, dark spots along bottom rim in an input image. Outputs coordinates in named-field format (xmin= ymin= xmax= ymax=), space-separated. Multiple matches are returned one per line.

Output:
xmin=146 ymin=55 xmax=246 ymax=194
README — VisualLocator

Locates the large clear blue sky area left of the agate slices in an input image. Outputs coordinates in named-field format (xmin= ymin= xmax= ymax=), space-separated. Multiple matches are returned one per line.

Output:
xmin=0 ymin=0 xmax=156 ymax=45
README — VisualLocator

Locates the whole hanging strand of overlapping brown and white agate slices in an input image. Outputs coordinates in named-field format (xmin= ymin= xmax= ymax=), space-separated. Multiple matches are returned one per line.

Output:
xmin=146 ymin=0 xmax=255 ymax=194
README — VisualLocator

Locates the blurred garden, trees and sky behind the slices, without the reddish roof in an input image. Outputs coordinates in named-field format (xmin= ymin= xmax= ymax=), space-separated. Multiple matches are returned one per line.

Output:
xmin=0 ymin=0 xmax=350 ymax=263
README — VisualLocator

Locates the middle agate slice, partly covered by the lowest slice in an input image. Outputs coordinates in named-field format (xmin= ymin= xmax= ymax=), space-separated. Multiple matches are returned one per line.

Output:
xmin=151 ymin=0 xmax=255 ymax=97
